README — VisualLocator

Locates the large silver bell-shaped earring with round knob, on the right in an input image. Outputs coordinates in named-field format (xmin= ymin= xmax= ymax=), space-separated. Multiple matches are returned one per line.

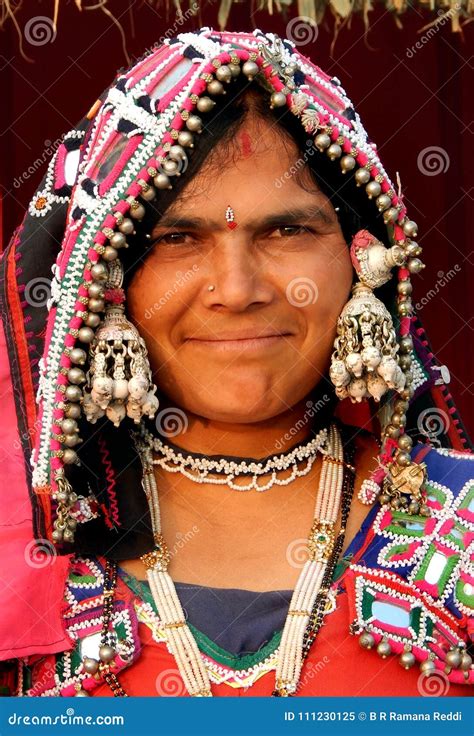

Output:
xmin=329 ymin=230 xmax=405 ymax=402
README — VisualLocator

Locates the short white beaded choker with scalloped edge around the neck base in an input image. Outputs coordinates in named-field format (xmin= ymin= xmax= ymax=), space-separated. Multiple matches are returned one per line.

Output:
xmin=143 ymin=429 xmax=328 ymax=491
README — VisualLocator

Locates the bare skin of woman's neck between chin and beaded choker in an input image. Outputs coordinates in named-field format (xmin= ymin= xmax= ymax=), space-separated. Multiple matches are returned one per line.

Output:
xmin=151 ymin=388 xmax=334 ymax=459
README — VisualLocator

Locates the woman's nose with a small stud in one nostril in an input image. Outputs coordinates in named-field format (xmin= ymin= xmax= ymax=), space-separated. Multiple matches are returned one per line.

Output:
xmin=205 ymin=236 xmax=275 ymax=312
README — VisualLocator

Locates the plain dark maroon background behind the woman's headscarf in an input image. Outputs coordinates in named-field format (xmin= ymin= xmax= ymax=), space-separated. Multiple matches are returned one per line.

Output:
xmin=0 ymin=2 xmax=474 ymax=434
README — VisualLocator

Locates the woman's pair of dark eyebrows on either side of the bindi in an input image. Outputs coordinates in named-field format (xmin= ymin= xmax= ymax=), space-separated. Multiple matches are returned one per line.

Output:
xmin=154 ymin=205 xmax=337 ymax=230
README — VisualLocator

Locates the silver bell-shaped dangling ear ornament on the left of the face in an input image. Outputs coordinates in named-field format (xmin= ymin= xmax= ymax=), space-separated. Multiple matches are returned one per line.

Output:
xmin=83 ymin=260 xmax=159 ymax=427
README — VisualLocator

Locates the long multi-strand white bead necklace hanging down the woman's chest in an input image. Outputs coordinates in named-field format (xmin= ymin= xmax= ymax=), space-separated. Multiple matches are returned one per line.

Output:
xmin=134 ymin=424 xmax=344 ymax=697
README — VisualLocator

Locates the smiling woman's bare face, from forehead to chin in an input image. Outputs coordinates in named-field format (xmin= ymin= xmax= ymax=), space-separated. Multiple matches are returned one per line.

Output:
xmin=127 ymin=119 xmax=352 ymax=423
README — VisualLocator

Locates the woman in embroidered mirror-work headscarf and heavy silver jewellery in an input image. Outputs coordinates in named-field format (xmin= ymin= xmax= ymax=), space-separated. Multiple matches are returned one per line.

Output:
xmin=0 ymin=28 xmax=474 ymax=697
